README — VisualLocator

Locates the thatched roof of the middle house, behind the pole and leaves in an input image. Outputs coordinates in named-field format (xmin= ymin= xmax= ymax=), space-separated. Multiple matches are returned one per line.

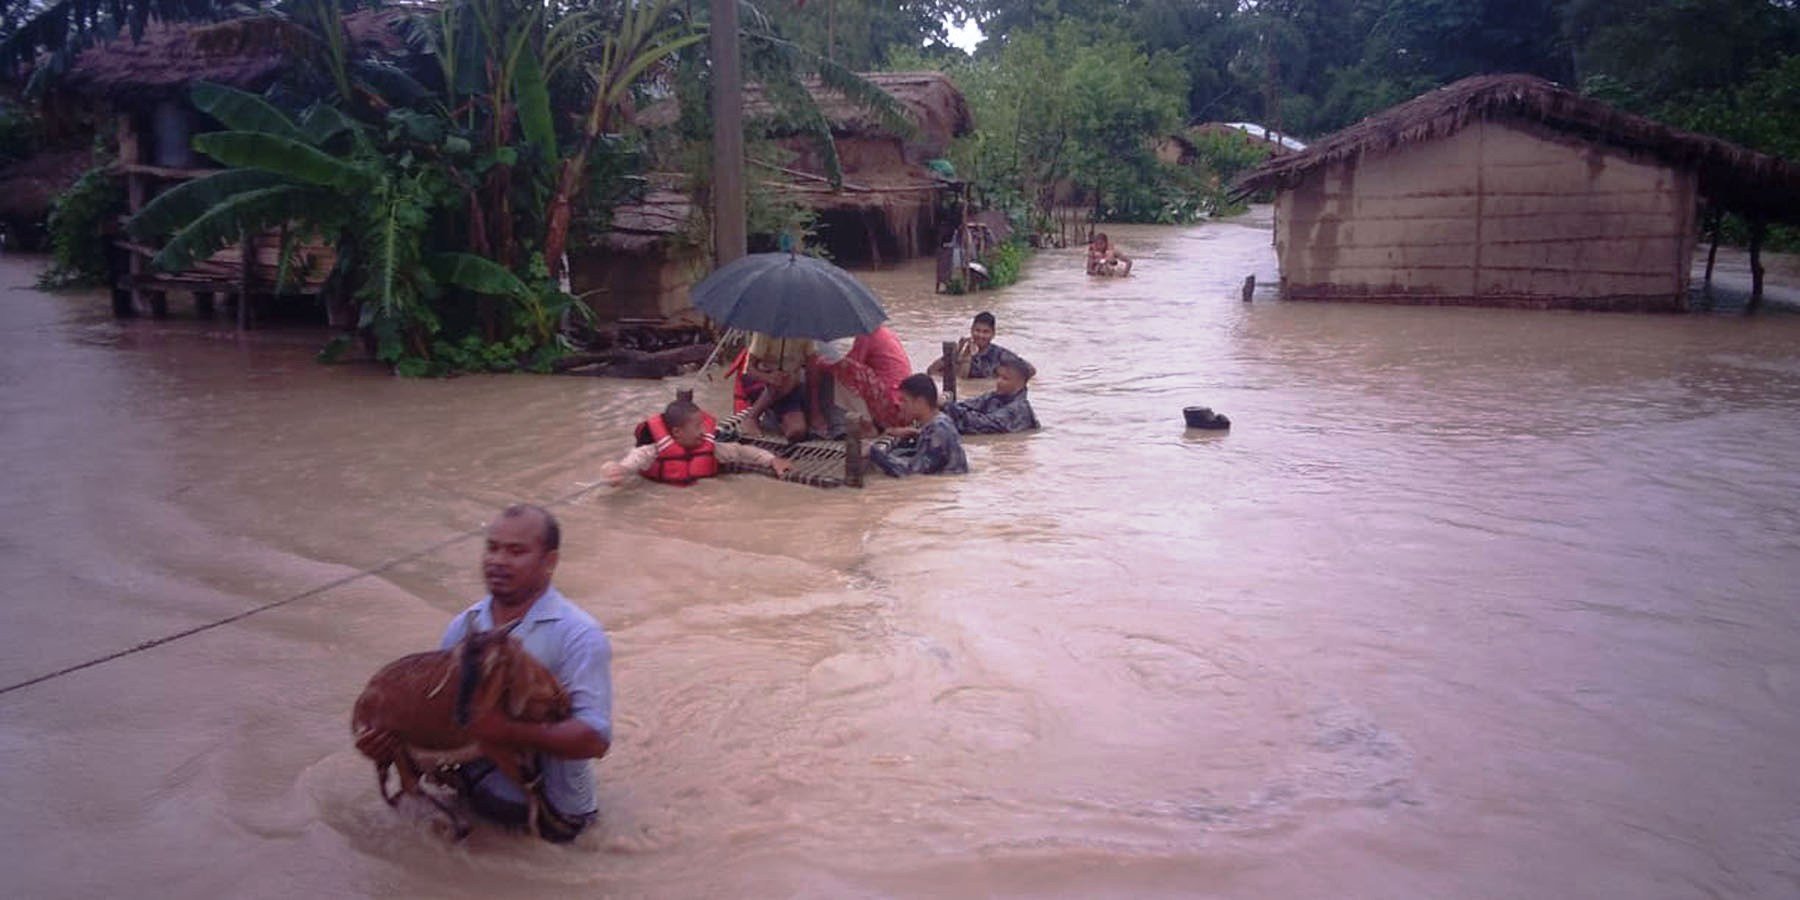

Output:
xmin=637 ymin=72 xmax=976 ymax=153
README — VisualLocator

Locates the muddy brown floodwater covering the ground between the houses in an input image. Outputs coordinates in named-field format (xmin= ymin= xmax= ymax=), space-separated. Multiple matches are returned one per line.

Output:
xmin=0 ymin=214 xmax=1800 ymax=898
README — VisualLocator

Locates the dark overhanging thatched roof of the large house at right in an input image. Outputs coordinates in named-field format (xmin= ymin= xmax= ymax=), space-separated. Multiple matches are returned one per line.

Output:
xmin=1235 ymin=76 xmax=1800 ymax=221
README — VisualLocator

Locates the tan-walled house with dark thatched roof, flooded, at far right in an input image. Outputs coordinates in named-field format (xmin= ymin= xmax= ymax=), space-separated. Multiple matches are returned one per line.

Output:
xmin=1238 ymin=76 xmax=1800 ymax=310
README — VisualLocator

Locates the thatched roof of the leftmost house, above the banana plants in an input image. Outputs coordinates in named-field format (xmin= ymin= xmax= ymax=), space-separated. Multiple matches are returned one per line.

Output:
xmin=61 ymin=11 xmax=405 ymax=103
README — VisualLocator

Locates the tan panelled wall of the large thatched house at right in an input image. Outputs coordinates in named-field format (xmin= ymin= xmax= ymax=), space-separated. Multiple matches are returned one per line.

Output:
xmin=1276 ymin=122 xmax=1697 ymax=310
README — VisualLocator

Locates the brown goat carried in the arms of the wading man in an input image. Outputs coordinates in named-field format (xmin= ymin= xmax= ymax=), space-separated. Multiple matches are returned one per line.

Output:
xmin=349 ymin=623 xmax=571 ymax=839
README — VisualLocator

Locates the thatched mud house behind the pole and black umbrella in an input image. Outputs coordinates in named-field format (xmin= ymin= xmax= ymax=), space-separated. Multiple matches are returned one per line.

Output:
xmin=637 ymin=72 xmax=974 ymax=263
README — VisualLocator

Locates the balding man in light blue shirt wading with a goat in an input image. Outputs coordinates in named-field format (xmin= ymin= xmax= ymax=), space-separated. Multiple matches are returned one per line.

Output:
xmin=356 ymin=506 xmax=612 ymax=842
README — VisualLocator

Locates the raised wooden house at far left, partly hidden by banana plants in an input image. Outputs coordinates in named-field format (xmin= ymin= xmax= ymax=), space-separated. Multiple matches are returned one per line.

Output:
xmin=49 ymin=13 xmax=405 ymax=324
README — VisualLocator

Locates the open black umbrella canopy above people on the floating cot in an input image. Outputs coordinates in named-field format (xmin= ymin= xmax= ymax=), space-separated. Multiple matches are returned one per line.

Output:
xmin=693 ymin=254 xmax=887 ymax=340
